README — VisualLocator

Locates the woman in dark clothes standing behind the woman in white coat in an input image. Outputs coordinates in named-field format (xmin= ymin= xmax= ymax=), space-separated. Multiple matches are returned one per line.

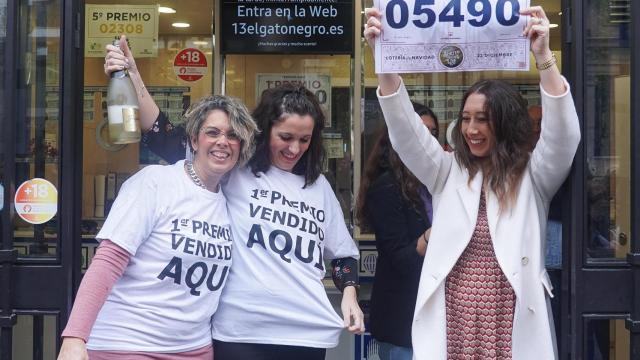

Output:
xmin=356 ymin=119 xmax=433 ymax=360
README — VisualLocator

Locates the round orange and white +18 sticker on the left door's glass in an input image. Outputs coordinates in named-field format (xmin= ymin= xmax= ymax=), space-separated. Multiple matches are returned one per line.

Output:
xmin=14 ymin=178 xmax=58 ymax=224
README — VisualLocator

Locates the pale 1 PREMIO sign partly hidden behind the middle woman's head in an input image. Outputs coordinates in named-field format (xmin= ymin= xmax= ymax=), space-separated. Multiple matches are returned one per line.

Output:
xmin=256 ymin=74 xmax=331 ymax=128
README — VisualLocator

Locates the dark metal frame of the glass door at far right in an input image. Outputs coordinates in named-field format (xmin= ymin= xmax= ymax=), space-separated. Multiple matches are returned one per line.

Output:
xmin=559 ymin=0 xmax=640 ymax=359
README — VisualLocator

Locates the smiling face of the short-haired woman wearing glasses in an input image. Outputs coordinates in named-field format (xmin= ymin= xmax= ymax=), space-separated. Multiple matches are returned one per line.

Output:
xmin=191 ymin=110 xmax=240 ymax=183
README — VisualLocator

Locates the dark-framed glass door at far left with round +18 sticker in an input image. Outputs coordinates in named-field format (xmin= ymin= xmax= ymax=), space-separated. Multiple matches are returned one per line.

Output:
xmin=0 ymin=0 xmax=82 ymax=360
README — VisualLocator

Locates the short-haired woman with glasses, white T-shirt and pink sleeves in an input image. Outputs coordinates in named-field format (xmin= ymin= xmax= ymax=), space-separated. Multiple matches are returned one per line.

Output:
xmin=58 ymin=96 xmax=257 ymax=360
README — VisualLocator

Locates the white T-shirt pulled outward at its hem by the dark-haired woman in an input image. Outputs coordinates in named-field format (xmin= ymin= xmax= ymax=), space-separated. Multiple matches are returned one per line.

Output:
xmin=212 ymin=166 xmax=358 ymax=348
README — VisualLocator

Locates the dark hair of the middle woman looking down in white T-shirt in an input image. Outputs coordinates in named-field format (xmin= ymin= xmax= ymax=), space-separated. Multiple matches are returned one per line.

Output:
xmin=249 ymin=84 xmax=325 ymax=188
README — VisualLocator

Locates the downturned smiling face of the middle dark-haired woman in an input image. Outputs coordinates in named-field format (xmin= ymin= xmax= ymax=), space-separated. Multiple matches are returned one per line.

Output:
xmin=269 ymin=114 xmax=314 ymax=172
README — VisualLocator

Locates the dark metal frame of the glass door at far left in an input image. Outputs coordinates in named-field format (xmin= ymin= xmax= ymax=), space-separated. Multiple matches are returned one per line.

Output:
xmin=0 ymin=0 xmax=84 ymax=360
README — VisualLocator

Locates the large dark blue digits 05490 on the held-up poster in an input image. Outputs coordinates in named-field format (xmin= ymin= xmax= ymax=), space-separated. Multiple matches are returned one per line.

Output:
xmin=385 ymin=0 xmax=520 ymax=29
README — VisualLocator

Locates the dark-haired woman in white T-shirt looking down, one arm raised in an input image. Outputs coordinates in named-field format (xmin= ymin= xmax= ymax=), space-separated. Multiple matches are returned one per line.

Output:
xmin=105 ymin=36 xmax=364 ymax=360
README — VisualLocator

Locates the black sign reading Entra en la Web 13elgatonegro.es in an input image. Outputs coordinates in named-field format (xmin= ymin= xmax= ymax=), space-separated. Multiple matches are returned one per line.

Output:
xmin=220 ymin=0 xmax=355 ymax=54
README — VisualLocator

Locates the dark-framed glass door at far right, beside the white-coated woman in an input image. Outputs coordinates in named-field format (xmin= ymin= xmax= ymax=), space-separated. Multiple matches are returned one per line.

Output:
xmin=563 ymin=0 xmax=640 ymax=360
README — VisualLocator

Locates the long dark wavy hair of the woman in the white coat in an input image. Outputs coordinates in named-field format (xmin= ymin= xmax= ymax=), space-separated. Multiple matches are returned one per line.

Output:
xmin=452 ymin=80 xmax=533 ymax=210
